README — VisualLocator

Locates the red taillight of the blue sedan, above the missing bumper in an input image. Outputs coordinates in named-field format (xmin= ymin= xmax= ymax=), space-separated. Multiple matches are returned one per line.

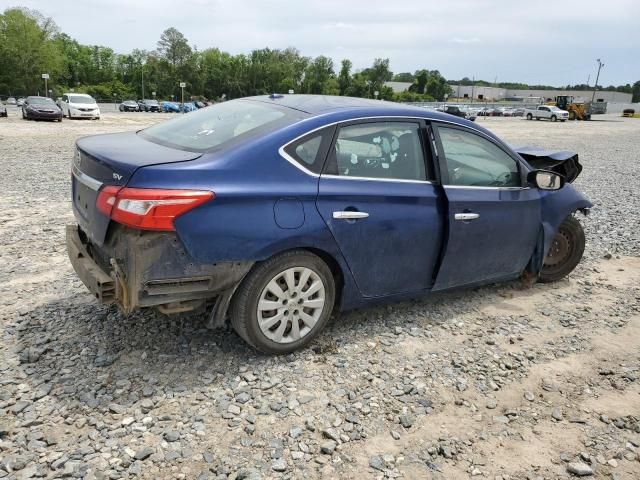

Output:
xmin=96 ymin=185 xmax=215 ymax=230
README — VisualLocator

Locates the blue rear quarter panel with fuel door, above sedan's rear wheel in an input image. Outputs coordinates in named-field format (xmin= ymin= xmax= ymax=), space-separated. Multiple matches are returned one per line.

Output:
xmin=128 ymin=122 xmax=359 ymax=308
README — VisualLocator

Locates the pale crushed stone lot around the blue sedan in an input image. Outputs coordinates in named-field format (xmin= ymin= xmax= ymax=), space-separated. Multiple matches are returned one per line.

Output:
xmin=0 ymin=109 xmax=640 ymax=480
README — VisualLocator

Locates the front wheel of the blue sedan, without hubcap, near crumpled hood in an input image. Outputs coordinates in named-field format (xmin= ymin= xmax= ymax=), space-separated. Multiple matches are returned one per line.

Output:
xmin=539 ymin=215 xmax=586 ymax=283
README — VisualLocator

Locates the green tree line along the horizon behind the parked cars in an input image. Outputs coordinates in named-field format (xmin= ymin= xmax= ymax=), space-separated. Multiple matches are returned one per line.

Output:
xmin=0 ymin=8 xmax=640 ymax=101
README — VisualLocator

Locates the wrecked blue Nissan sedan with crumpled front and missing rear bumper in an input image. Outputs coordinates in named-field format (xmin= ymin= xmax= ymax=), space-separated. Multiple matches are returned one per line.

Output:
xmin=67 ymin=95 xmax=591 ymax=354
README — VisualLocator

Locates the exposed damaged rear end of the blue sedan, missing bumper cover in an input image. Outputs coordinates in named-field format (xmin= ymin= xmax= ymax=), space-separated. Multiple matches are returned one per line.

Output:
xmin=66 ymin=225 xmax=253 ymax=323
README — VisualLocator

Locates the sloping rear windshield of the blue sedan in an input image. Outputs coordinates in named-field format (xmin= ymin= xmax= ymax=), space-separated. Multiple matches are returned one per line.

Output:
xmin=139 ymin=100 xmax=303 ymax=152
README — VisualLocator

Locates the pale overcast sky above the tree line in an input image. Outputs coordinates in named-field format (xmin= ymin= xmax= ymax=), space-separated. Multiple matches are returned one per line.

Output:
xmin=5 ymin=0 xmax=640 ymax=86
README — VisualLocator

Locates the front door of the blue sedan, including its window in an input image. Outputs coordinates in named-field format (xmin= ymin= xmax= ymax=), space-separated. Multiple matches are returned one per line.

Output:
xmin=432 ymin=123 xmax=541 ymax=290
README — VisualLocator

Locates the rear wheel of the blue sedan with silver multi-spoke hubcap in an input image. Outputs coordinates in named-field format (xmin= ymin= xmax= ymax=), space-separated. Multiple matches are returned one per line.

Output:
xmin=231 ymin=250 xmax=335 ymax=355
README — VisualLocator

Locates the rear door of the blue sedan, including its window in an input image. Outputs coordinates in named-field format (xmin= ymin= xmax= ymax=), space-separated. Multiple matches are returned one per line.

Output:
xmin=316 ymin=118 xmax=444 ymax=297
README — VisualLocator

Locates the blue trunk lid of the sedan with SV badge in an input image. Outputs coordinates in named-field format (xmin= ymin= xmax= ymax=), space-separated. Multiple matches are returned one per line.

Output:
xmin=71 ymin=132 xmax=202 ymax=245
